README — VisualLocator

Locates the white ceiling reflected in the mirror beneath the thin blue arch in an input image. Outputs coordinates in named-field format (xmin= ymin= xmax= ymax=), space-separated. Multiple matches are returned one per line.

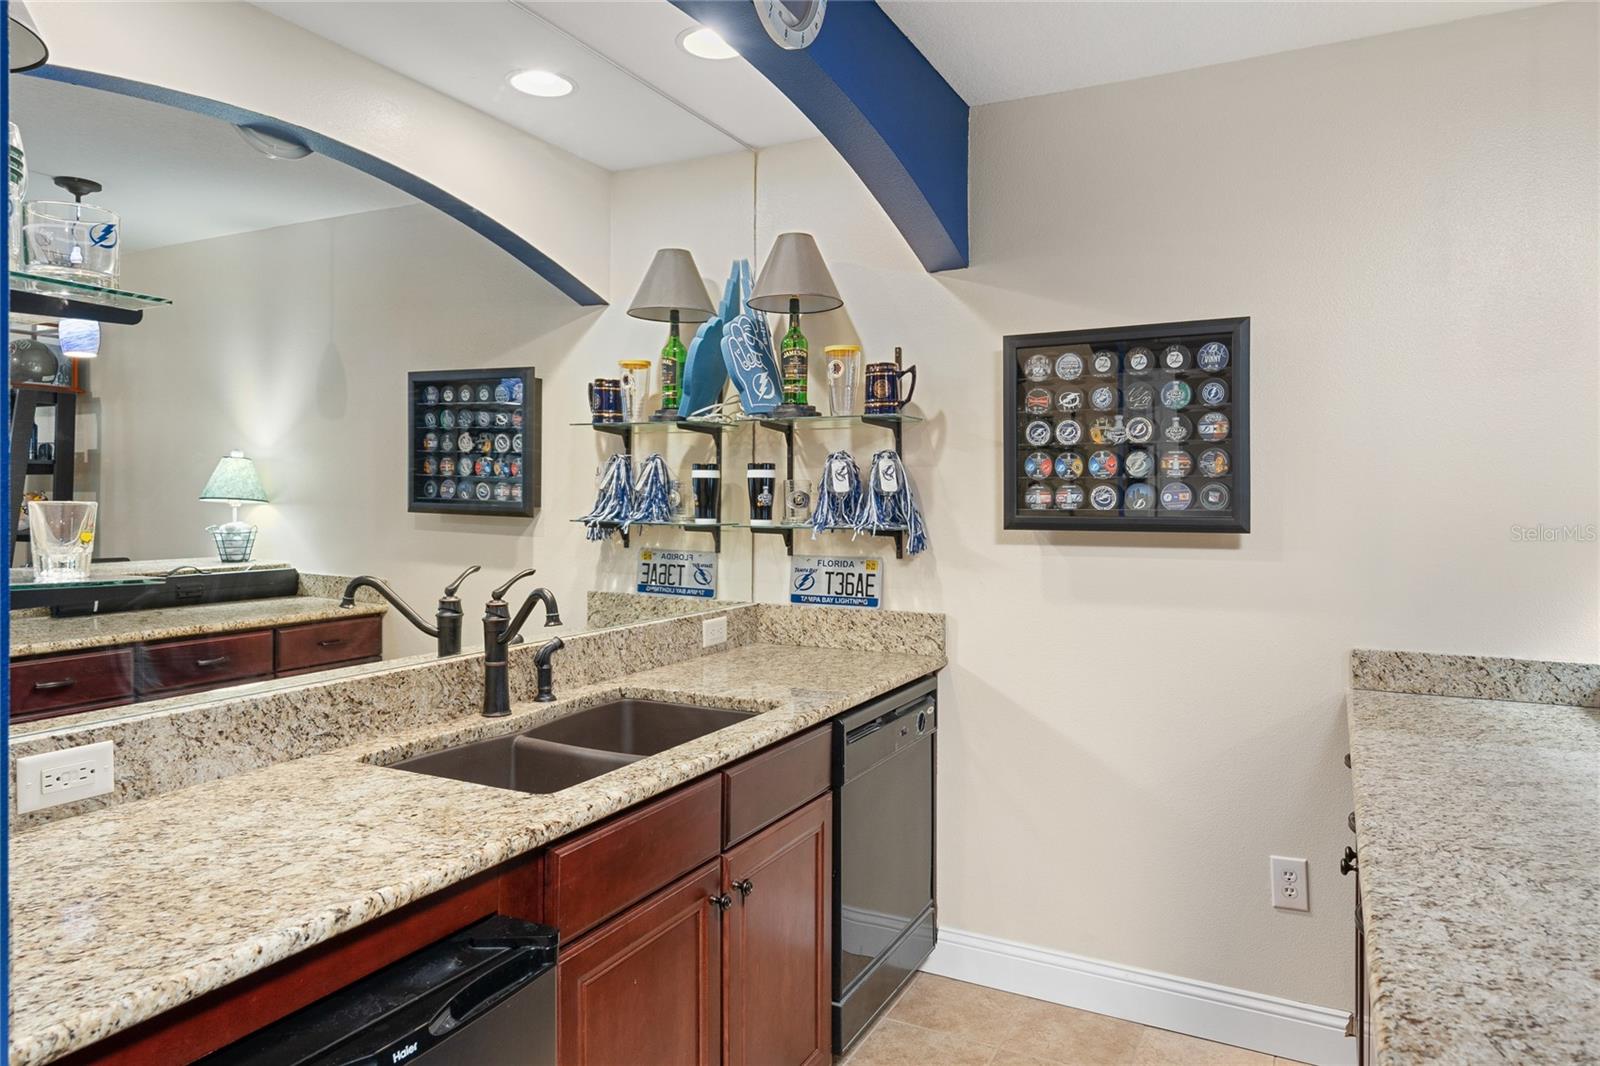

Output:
xmin=10 ymin=75 xmax=416 ymax=251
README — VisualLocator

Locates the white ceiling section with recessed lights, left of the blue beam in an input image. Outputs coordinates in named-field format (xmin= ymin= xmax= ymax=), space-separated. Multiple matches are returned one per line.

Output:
xmin=256 ymin=0 xmax=818 ymax=170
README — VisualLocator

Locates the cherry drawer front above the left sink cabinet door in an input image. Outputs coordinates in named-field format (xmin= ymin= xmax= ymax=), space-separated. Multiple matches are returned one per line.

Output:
xmin=544 ymin=776 xmax=722 ymax=943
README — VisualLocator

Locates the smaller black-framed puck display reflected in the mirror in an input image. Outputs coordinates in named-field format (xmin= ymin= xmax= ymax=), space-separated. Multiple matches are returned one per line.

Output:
xmin=406 ymin=367 xmax=541 ymax=517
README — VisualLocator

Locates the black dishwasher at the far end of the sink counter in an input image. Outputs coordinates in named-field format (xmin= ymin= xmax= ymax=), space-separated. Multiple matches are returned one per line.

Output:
xmin=834 ymin=677 xmax=938 ymax=1052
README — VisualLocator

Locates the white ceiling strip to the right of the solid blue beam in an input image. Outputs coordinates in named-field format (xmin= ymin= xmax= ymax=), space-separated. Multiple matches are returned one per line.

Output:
xmin=876 ymin=0 xmax=1534 ymax=104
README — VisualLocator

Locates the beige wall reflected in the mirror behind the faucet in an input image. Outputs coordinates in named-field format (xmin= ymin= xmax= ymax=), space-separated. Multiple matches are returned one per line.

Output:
xmin=103 ymin=148 xmax=750 ymax=653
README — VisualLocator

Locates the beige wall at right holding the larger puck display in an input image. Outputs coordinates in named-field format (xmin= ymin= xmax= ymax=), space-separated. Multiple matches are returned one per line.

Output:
xmin=757 ymin=5 xmax=1600 ymax=1007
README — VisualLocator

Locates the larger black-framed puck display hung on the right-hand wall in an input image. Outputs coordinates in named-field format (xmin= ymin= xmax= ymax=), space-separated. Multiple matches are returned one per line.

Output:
xmin=1000 ymin=319 xmax=1250 ymax=533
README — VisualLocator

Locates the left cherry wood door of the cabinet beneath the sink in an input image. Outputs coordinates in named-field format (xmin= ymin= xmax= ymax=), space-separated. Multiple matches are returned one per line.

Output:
xmin=555 ymin=861 xmax=726 ymax=1066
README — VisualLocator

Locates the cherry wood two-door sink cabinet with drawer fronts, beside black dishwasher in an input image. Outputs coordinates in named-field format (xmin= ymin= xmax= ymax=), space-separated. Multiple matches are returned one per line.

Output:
xmin=556 ymin=727 xmax=834 ymax=1066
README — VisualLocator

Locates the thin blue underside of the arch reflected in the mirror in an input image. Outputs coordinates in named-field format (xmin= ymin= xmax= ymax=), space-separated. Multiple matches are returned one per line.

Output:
xmin=29 ymin=64 xmax=606 ymax=307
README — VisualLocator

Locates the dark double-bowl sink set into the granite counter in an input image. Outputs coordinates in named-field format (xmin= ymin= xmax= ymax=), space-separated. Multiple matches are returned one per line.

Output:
xmin=392 ymin=699 xmax=754 ymax=794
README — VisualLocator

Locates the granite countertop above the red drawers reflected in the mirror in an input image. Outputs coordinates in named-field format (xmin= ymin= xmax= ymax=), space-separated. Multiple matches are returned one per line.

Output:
xmin=11 ymin=595 xmax=389 ymax=659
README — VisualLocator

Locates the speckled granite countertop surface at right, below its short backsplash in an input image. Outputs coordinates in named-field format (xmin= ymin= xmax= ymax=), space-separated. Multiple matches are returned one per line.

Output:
xmin=1349 ymin=690 xmax=1600 ymax=1066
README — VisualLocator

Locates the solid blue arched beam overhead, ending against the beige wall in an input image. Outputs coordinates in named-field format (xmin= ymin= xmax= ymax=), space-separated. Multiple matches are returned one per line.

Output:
xmin=672 ymin=0 xmax=968 ymax=271
